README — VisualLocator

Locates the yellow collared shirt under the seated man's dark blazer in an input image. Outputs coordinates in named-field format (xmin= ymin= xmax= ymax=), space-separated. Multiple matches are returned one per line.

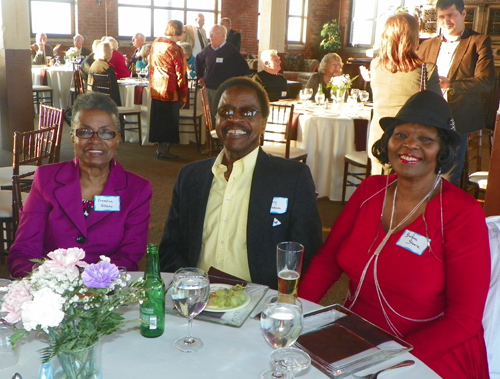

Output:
xmin=198 ymin=148 xmax=259 ymax=281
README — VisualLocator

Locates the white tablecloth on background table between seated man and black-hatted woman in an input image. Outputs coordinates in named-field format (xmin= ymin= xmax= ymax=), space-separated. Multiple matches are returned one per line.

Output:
xmin=296 ymin=104 xmax=370 ymax=201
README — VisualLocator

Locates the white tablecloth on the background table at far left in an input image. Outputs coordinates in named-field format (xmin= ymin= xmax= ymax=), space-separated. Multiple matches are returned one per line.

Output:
xmin=31 ymin=66 xmax=73 ymax=109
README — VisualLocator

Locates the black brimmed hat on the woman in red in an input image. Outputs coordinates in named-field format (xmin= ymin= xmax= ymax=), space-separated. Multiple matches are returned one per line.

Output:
xmin=380 ymin=91 xmax=460 ymax=146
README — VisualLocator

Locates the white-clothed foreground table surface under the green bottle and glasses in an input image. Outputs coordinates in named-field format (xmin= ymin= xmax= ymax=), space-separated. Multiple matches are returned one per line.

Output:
xmin=0 ymin=273 xmax=439 ymax=379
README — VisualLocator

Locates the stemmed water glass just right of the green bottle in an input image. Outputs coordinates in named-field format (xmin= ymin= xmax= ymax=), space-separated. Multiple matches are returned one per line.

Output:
xmin=171 ymin=267 xmax=210 ymax=353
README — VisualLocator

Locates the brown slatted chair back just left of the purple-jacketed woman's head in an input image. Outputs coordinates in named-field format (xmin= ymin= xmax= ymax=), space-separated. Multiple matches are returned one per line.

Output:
xmin=12 ymin=126 xmax=58 ymax=175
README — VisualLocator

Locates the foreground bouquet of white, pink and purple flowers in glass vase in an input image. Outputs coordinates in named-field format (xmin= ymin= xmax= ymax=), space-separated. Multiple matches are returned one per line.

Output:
xmin=2 ymin=248 xmax=144 ymax=379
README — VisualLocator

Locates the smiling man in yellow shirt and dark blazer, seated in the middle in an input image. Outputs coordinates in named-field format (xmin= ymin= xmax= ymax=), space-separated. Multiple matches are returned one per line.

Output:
xmin=160 ymin=77 xmax=322 ymax=288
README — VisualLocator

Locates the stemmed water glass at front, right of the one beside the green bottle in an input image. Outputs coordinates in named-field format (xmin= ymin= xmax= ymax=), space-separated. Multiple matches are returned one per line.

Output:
xmin=260 ymin=294 xmax=310 ymax=379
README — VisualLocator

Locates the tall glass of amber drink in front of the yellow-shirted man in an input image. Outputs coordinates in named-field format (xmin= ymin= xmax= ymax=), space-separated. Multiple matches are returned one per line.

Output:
xmin=276 ymin=241 xmax=304 ymax=297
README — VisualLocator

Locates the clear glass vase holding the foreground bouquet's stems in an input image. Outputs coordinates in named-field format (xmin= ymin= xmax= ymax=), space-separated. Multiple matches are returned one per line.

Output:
xmin=39 ymin=342 xmax=102 ymax=379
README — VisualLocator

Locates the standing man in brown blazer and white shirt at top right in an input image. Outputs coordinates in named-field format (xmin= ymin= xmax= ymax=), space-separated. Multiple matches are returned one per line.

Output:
xmin=418 ymin=0 xmax=495 ymax=184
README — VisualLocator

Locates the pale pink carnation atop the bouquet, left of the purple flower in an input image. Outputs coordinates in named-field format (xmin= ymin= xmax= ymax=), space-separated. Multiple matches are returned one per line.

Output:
xmin=43 ymin=247 xmax=87 ymax=280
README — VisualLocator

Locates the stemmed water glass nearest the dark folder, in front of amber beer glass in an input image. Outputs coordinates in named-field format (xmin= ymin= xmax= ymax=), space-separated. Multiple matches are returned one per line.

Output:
xmin=260 ymin=294 xmax=303 ymax=379
